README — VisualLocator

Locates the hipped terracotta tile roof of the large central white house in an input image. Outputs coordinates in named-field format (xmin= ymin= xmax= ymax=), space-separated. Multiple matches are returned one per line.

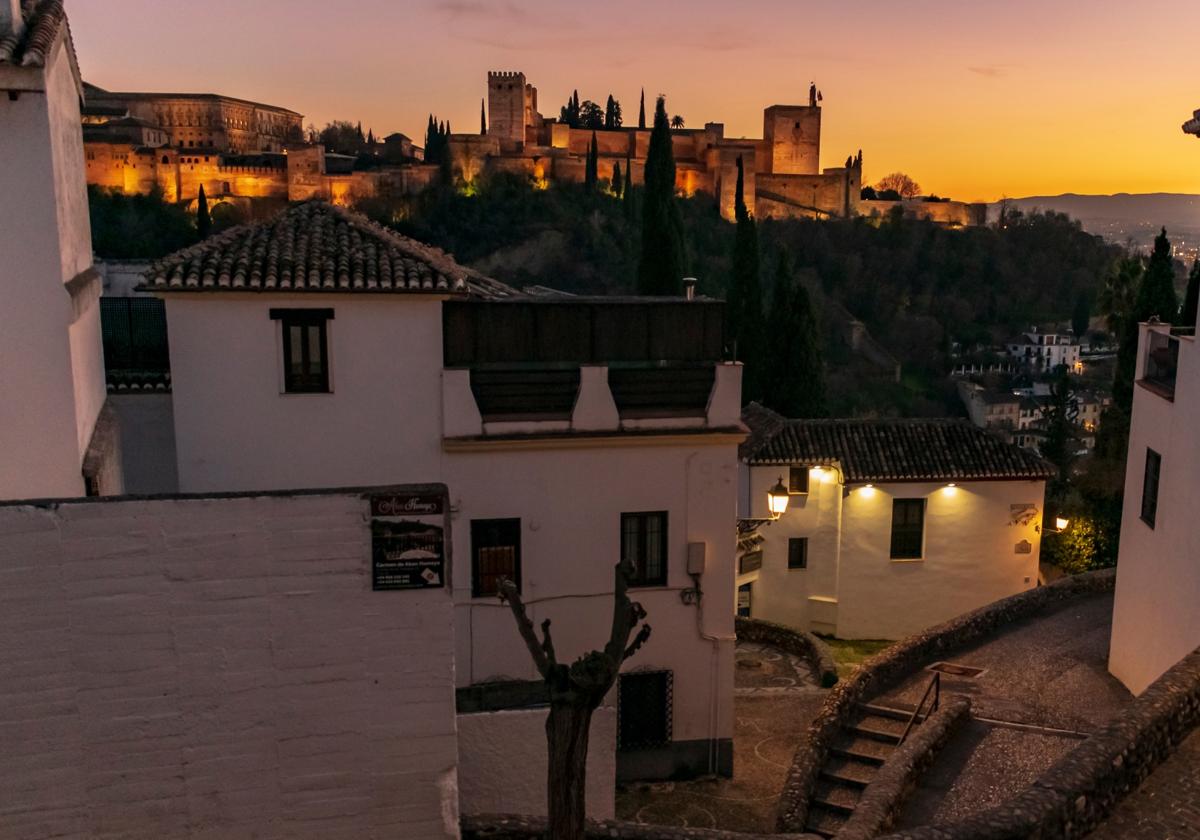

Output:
xmin=139 ymin=200 xmax=520 ymax=299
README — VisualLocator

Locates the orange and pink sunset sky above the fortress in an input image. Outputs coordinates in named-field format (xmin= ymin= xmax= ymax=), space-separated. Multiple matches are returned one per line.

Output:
xmin=67 ymin=0 xmax=1200 ymax=200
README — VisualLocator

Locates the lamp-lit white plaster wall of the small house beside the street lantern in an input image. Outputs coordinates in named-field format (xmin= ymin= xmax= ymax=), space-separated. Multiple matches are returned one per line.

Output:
xmin=743 ymin=467 xmax=1045 ymax=638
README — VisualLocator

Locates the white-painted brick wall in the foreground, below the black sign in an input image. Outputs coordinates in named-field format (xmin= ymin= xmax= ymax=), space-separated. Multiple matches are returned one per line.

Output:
xmin=0 ymin=494 xmax=458 ymax=840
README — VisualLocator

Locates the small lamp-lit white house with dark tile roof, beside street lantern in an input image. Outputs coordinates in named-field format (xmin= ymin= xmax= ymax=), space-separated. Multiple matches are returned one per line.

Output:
xmin=737 ymin=403 xmax=1054 ymax=638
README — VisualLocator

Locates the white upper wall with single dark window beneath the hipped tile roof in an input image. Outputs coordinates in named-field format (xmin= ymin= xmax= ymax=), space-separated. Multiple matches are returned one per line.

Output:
xmin=167 ymin=293 xmax=451 ymax=492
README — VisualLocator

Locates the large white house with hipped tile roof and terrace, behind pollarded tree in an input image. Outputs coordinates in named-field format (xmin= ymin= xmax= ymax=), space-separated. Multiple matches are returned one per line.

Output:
xmin=146 ymin=202 xmax=744 ymax=782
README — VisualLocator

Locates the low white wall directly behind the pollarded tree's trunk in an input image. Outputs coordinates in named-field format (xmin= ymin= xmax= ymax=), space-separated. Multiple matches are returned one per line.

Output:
xmin=458 ymin=706 xmax=617 ymax=820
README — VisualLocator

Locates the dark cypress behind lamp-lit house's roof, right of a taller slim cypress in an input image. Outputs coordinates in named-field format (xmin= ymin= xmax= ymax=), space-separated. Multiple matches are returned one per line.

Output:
xmin=762 ymin=253 xmax=826 ymax=418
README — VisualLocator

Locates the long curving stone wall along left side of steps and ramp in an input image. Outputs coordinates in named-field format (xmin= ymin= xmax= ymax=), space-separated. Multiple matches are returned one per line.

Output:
xmin=776 ymin=569 xmax=1116 ymax=833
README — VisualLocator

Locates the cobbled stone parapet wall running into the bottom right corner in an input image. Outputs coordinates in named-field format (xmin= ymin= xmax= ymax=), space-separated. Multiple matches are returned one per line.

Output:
xmin=881 ymin=648 xmax=1200 ymax=840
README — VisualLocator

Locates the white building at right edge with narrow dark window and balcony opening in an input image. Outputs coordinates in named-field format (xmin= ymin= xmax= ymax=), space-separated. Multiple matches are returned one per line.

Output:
xmin=1109 ymin=324 xmax=1200 ymax=694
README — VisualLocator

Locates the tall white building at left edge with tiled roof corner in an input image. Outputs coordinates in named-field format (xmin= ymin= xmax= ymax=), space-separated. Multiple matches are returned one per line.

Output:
xmin=0 ymin=0 xmax=121 ymax=499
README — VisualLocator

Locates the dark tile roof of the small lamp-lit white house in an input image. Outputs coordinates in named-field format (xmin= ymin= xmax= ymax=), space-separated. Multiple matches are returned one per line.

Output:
xmin=740 ymin=403 xmax=1055 ymax=482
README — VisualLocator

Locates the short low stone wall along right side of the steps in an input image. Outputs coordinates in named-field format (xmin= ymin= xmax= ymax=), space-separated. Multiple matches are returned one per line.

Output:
xmin=838 ymin=697 xmax=971 ymax=840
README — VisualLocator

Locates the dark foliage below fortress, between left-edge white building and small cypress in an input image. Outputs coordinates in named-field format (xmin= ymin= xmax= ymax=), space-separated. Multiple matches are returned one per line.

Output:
xmin=88 ymin=186 xmax=198 ymax=259
